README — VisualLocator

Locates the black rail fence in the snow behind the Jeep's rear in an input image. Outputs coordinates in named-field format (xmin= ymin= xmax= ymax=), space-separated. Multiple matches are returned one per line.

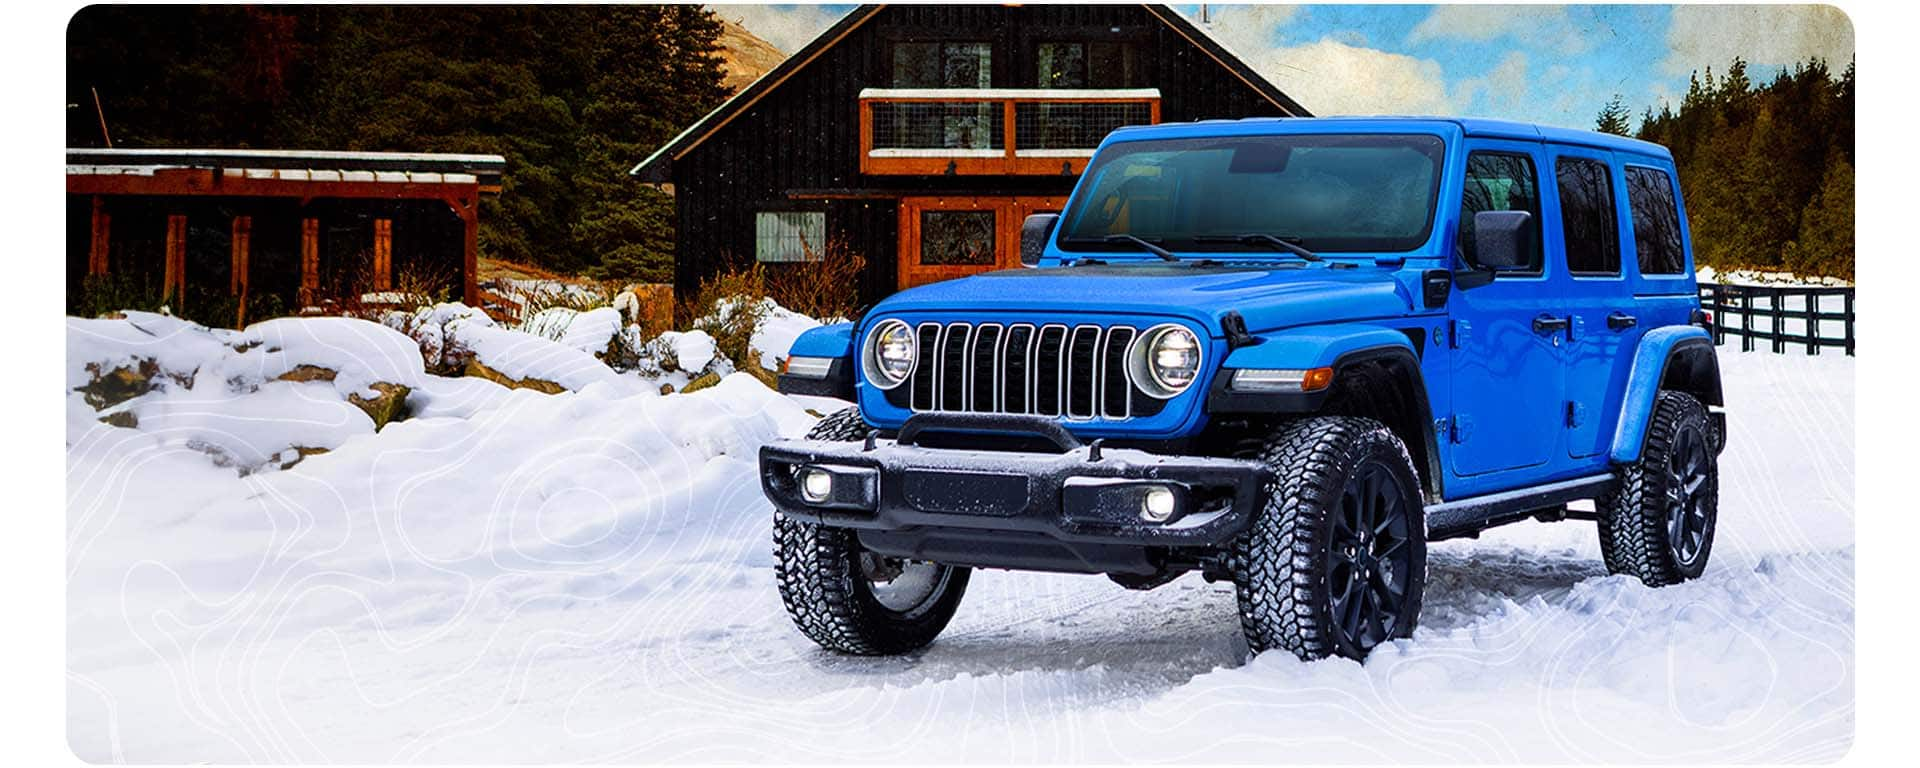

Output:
xmin=1699 ymin=282 xmax=1853 ymax=355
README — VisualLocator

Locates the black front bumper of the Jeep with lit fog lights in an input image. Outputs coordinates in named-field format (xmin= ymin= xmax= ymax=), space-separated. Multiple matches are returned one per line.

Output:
xmin=760 ymin=417 xmax=1271 ymax=574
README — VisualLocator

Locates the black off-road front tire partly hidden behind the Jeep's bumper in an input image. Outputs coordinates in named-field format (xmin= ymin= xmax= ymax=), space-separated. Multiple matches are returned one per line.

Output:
xmin=774 ymin=409 xmax=972 ymax=657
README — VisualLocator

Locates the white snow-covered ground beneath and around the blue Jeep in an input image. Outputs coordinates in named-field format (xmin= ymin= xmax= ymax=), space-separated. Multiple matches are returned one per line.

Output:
xmin=67 ymin=318 xmax=1855 ymax=762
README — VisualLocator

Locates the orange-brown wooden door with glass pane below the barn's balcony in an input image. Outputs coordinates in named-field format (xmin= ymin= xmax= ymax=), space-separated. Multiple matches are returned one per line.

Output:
xmin=899 ymin=196 xmax=1068 ymax=290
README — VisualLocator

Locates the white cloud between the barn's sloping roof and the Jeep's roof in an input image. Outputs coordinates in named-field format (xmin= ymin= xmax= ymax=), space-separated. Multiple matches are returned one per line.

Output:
xmin=1242 ymin=38 xmax=1453 ymax=115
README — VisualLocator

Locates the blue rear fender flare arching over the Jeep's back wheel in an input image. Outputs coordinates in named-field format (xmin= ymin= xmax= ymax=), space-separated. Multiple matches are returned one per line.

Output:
xmin=1607 ymin=324 xmax=1724 ymax=465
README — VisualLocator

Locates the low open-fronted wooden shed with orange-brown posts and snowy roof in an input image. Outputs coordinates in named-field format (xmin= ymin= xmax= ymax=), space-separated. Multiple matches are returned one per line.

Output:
xmin=67 ymin=150 xmax=507 ymax=323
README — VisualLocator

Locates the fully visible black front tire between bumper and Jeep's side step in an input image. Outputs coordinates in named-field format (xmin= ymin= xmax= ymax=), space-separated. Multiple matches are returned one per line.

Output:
xmin=1231 ymin=417 xmax=1427 ymax=660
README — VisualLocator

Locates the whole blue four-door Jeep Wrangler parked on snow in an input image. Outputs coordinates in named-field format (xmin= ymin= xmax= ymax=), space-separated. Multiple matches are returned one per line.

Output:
xmin=760 ymin=117 xmax=1726 ymax=659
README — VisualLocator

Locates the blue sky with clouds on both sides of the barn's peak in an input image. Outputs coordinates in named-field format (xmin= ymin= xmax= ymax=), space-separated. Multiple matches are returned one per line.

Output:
xmin=712 ymin=4 xmax=1853 ymax=129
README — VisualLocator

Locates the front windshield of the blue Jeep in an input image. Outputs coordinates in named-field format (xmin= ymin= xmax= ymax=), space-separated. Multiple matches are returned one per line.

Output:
xmin=1060 ymin=134 xmax=1444 ymax=252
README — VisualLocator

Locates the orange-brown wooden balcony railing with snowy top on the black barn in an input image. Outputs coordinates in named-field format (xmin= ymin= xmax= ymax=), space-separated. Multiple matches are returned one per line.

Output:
xmin=860 ymin=88 xmax=1160 ymax=177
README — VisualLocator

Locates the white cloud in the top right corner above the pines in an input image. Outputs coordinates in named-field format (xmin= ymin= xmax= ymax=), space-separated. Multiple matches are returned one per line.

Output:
xmin=1663 ymin=6 xmax=1853 ymax=75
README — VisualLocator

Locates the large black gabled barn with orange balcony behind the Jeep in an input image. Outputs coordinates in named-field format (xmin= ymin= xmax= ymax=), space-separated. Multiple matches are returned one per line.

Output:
xmin=632 ymin=4 xmax=1308 ymax=300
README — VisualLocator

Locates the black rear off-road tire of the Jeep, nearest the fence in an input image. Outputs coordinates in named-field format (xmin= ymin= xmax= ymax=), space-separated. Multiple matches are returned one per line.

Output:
xmin=1599 ymin=392 xmax=1720 ymax=588
